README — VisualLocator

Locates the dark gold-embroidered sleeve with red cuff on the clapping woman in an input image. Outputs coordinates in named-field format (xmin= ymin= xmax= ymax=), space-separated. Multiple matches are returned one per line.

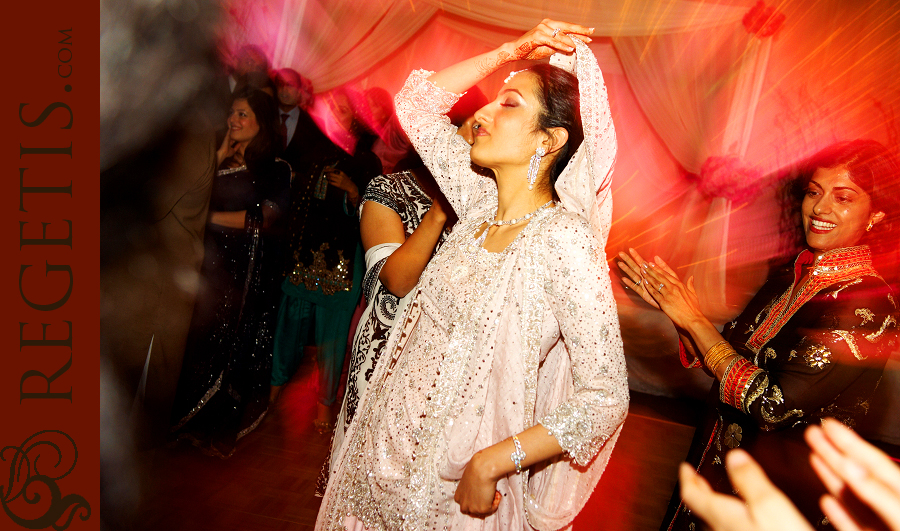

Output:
xmin=736 ymin=282 xmax=896 ymax=430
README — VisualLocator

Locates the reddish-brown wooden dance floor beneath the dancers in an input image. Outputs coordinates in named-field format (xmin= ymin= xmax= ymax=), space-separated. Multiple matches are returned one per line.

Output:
xmin=138 ymin=355 xmax=694 ymax=531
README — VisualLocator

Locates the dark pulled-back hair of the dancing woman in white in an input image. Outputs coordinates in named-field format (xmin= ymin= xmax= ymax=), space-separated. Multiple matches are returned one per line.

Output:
xmin=528 ymin=64 xmax=584 ymax=195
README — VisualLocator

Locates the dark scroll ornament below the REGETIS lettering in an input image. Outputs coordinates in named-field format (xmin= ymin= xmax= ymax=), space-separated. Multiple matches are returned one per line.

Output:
xmin=0 ymin=430 xmax=91 ymax=531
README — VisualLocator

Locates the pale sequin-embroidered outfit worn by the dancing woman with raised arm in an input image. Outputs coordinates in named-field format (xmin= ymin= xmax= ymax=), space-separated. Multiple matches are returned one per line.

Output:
xmin=316 ymin=40 xmax=628 ymax=530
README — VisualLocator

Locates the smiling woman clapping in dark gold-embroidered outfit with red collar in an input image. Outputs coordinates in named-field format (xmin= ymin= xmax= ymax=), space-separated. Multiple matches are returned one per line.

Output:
xmin=619 ymin=140 xmax=900 ymax=529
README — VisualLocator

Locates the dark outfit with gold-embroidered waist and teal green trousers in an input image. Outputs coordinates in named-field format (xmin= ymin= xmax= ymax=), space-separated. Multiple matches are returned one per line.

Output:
xmin=271 ymin=134 xmax=381 ymax=406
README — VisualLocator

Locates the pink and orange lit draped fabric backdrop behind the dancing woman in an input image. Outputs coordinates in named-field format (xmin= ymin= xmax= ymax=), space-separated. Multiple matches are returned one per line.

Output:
xmin=222 ymin=0 xmax=900 ymax=442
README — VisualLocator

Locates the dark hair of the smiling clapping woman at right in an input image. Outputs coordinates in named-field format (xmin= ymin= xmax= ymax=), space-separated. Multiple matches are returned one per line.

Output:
xmin=782 ymin=139 xmax=900 ymax=274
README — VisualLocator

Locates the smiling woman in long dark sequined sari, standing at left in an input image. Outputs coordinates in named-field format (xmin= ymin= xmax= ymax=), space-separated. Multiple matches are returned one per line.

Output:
xmin=172 ymin=88 xmax=291 ymax=458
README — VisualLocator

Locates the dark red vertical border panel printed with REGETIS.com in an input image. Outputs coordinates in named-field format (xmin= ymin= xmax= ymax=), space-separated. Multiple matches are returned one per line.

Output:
xmin=0 ymin=0 xmax=100 ymax=530
